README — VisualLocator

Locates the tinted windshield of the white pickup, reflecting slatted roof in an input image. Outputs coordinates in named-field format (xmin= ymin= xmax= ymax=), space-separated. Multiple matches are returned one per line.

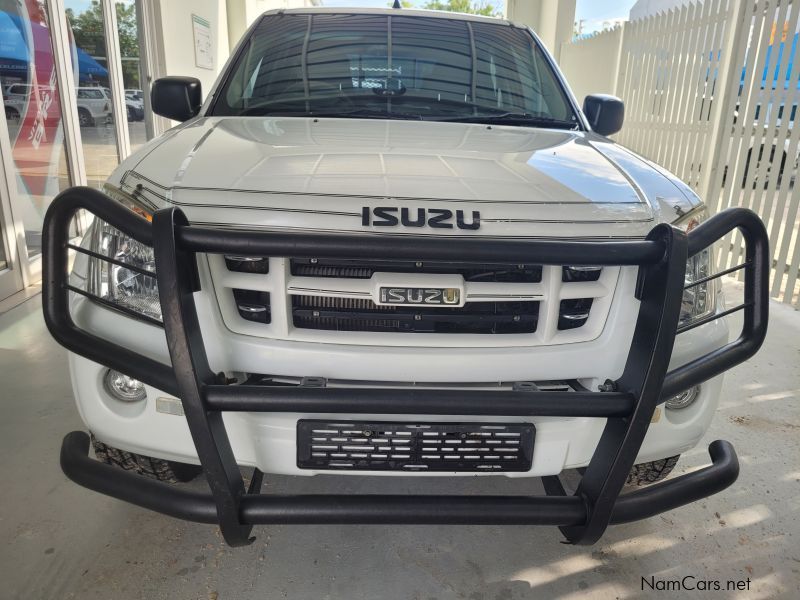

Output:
xmin=209 ymin=14 xmax=578 ymax=129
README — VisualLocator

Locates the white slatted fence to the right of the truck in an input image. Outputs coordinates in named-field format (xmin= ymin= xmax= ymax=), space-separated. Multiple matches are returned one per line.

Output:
xmin=561 ymin=0 xmax=800 ymax=307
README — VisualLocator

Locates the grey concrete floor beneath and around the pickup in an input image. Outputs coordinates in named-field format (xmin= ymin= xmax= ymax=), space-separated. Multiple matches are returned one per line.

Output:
xmin=0 ymin=288 xmax=800 ymax=600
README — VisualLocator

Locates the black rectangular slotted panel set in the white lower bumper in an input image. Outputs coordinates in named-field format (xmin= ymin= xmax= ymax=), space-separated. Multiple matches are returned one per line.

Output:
xmin=297 ymin=419 xmax=535 ymax=472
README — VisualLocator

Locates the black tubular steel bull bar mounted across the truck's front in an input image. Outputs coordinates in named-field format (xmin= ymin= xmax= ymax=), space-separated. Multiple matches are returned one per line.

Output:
xmin=43 ymin=187 xmax=769 ymax=546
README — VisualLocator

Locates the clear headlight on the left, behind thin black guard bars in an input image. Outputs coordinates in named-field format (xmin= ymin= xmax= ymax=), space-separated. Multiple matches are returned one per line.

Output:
xmin=83 ymin=219 xmax=162 ymax=321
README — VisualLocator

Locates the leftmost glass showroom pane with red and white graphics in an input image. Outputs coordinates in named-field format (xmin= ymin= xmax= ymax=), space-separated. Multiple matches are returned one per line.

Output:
xmin=0 ymin=0 xmax=70 ymax=258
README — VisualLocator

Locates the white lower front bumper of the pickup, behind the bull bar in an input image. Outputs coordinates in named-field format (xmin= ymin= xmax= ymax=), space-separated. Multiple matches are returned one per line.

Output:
xmin=69 ymin=350 xmax=728 ymax=479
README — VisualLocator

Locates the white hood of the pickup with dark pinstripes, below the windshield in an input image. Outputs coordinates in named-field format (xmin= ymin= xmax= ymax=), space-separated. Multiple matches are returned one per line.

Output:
xmin=114 ymin=117 xmax=700 ymax=237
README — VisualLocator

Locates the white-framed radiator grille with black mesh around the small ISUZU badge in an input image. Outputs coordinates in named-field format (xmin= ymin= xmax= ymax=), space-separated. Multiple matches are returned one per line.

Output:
xmin=207 ymin=255 xmax=620 ymax=347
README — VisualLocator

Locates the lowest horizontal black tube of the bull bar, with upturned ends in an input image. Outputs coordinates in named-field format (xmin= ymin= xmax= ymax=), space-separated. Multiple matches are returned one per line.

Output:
xmin=61 ymin=431 xmax=739 ymax=526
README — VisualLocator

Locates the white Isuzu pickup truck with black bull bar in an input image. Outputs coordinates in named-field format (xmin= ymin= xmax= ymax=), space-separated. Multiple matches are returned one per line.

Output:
xmin=44 ymin=9 xmax=769 ymax=545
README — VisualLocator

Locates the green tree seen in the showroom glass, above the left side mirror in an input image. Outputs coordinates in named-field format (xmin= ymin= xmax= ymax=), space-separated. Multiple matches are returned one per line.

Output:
xmin=66 ymin=0 xmax=141 ymax=89
